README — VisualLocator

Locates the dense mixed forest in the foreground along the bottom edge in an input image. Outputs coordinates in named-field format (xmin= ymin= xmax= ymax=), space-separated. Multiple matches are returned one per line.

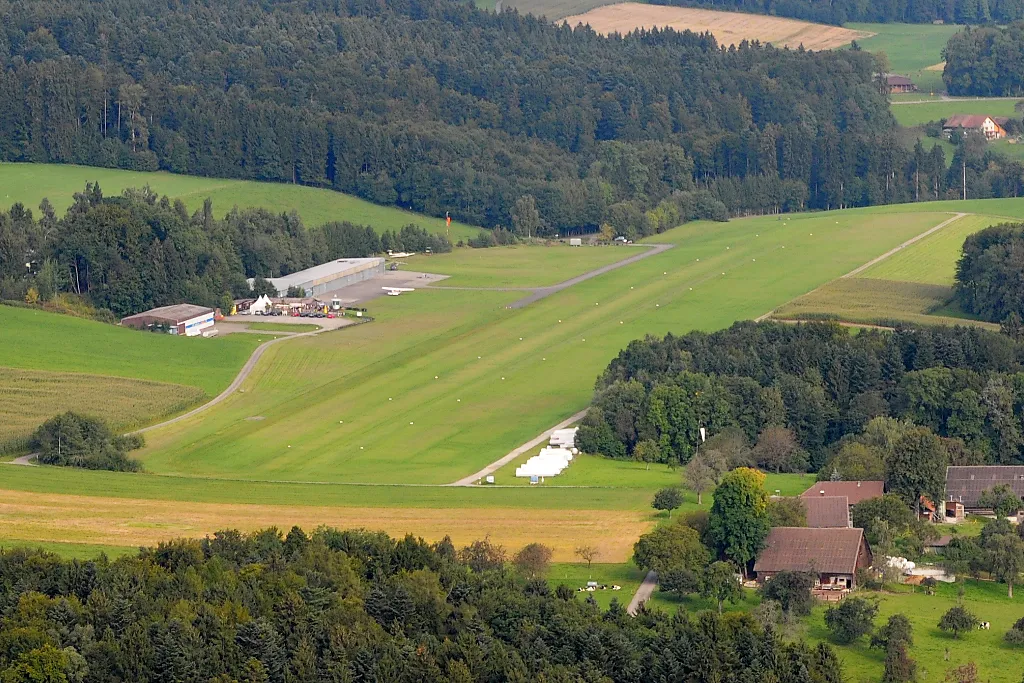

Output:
xmin=0 ymin=528 xmax=843 ymax=683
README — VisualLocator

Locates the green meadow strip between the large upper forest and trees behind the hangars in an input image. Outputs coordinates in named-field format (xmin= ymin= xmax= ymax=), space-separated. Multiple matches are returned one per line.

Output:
xmin=0 ymin=163 xmax=479 ymax=242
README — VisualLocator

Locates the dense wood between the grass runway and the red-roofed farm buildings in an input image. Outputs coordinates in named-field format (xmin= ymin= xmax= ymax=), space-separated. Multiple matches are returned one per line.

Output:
xmin=577 ymin=323 xmax=1024 ymax=471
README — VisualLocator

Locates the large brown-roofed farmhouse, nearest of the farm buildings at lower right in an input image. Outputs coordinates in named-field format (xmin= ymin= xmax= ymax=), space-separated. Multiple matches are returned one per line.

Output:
xmin=754 ymin=526 xmax=871 ymax=590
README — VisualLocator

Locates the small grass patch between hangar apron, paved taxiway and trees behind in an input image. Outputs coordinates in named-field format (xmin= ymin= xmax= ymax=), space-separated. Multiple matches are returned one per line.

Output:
xmin=401 ymin=244 xmax=630 ymax=287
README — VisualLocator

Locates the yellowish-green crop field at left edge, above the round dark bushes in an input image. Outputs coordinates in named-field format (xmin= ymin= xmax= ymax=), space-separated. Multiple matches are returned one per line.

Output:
xmin=0 ymin=367 xmax=205 ymax=453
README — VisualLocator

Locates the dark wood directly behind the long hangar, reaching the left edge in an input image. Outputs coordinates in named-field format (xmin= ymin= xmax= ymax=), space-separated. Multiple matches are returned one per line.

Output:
xmin=0 ymin=184 xmax=452 ymax=316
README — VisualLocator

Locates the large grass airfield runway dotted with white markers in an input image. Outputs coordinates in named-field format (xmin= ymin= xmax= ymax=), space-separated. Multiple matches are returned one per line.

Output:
xmin=128 ymin=211 xmax=944 ymax=483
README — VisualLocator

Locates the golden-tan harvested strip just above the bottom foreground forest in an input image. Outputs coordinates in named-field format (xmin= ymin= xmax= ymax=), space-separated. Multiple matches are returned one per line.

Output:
xmin=0 ymin=493 xmax=653 ymax=562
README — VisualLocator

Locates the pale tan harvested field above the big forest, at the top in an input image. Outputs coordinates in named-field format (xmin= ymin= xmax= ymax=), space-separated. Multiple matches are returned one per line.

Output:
xmin=563 ymin=2 xmax=873 ymax=50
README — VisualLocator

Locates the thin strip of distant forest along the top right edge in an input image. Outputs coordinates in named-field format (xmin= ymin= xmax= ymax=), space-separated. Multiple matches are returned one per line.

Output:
xmin=652 ymin=0 xmax=1024 ymax=26
